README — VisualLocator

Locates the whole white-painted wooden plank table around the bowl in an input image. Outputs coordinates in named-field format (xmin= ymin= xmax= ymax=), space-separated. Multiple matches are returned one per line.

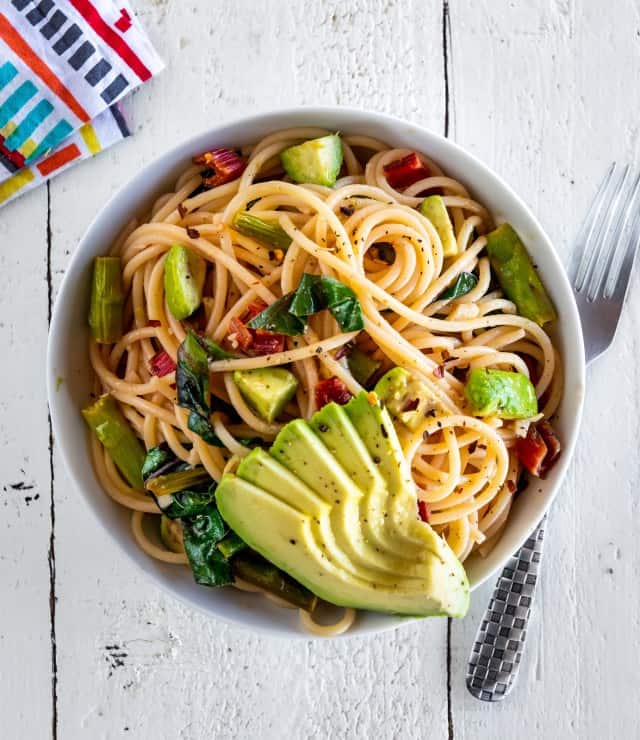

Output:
xmin=0 ymin=0 xmax=640 ymax=740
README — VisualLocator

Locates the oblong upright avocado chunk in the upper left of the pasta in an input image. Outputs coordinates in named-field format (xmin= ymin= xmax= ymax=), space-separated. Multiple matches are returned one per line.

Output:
xmin=164 ymin=244 xmax=206 ymax=321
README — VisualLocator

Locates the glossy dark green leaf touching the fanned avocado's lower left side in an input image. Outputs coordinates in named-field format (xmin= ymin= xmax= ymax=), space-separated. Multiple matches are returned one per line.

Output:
xmin=182 ymin=503 xmax=234 ymax=586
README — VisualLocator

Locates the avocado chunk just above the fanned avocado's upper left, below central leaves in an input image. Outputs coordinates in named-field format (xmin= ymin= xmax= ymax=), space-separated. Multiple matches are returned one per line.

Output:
xmin=233 ymin=367 xmax=298 ymax=422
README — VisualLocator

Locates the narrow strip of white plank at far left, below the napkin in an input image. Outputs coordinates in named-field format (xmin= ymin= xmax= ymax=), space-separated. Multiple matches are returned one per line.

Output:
xmin=0 ymin=188 xmax=52 ymax=738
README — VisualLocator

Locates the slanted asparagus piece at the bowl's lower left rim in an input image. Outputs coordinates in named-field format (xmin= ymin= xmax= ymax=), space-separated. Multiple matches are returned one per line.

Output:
xmin=82 ymin=393 xmax=145 ymax=491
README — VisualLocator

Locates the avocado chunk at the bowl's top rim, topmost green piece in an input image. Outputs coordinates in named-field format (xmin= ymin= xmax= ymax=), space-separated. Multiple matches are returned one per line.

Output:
xmin=280 ymin=134 xmax=342 ymax=188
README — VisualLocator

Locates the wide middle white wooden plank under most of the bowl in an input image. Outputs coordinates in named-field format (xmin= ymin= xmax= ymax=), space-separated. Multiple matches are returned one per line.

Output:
xmin=52 ymin=0 xmax=447 ymax=739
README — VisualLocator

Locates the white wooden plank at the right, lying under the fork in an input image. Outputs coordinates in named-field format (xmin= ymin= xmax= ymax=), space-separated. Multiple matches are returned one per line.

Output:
xmin=452 ymin=0 xmax=640 ymax=739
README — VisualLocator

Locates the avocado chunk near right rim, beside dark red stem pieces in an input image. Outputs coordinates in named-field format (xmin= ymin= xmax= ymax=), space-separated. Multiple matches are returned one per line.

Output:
xmin=464 ymin=368 xmax=538 ymax=419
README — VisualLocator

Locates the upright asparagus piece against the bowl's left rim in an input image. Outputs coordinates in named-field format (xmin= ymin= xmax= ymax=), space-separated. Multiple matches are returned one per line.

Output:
xmin=89 ymin=257 xmax=124 ymax=344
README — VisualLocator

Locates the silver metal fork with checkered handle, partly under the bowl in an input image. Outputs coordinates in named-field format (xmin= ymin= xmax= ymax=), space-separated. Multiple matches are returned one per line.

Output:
xmin=467 ymin=162 xmax=640 ymax=701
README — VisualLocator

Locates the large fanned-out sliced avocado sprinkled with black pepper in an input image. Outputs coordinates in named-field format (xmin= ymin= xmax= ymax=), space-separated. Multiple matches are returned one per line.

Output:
xmin=216 ymin=393 xmax=469 ymax=616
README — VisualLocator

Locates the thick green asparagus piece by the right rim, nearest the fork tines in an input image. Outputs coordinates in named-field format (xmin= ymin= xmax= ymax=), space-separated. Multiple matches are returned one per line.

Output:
xmin=487 ymin=224 xmax=557 ymax=326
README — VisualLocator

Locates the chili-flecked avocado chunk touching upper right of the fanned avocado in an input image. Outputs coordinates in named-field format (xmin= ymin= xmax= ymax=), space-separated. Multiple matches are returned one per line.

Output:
xmin=374 ymin=367 xmax=442 ymax=430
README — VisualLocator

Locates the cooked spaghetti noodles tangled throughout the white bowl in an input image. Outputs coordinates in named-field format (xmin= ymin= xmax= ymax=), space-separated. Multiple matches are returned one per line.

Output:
xmin=90 ymin=128 xmax=562 ymax=634
